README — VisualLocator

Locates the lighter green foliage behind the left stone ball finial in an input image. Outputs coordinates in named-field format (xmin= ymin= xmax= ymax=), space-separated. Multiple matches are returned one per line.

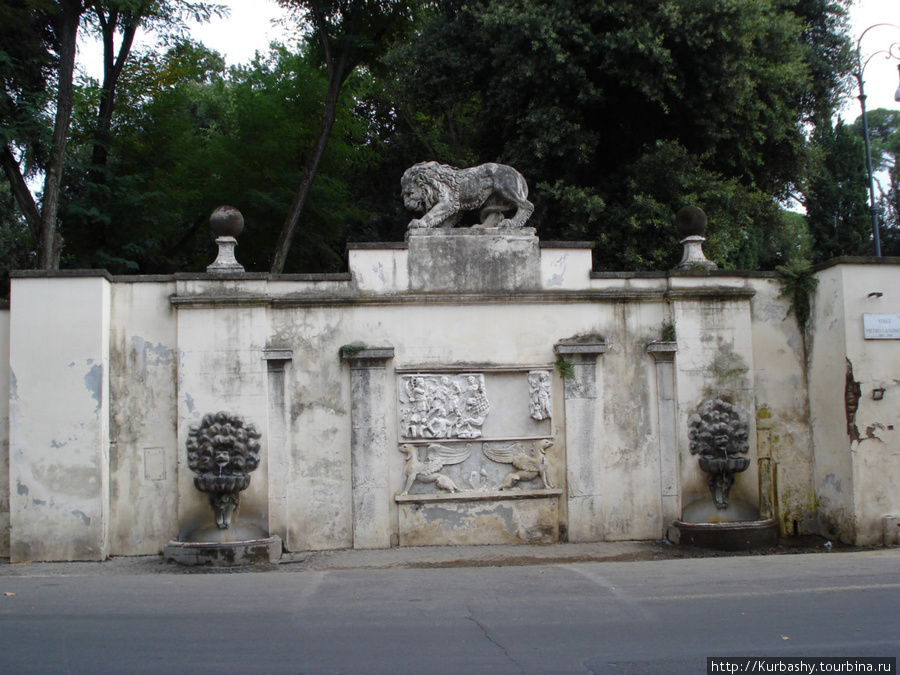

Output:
xmin=56 ymin=42 xmax=374 ymax=273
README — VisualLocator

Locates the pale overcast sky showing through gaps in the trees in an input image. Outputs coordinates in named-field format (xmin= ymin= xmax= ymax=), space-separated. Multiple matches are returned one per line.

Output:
xmin=79 ymin=0 xmax=900 ymax=121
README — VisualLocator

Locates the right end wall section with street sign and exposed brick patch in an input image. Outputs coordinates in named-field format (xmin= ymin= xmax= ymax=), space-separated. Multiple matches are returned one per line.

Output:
xmin=810 ymin=263 xmax=900 ymax=545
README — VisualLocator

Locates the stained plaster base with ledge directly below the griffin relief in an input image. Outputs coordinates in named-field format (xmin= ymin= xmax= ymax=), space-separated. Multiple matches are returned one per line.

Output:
xmin=396 ymin=490 xmax=562 ymax=546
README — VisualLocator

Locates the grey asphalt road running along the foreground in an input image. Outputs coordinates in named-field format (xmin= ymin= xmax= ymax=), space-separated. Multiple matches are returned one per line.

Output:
xmin=0 ymin=550 xmax=900 ymax=674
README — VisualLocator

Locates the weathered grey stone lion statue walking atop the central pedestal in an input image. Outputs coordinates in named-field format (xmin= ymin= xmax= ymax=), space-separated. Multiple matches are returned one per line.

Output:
xmin=400 ymin=162 xmax=534 ymax=229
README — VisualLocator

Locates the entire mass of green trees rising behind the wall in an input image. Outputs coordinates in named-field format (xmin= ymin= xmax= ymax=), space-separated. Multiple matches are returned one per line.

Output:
xmin=0 ymin=0 xmax=868 ymax=280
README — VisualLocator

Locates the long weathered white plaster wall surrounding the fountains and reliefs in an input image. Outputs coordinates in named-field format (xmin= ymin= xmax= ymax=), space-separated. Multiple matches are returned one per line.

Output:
xmin=10 ymin=256 xmax=900 ymax=560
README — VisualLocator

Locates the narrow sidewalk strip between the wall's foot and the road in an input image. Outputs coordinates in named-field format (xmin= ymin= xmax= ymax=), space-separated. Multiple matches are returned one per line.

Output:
xmin=0 ymin=537 xmax=856 ymax=577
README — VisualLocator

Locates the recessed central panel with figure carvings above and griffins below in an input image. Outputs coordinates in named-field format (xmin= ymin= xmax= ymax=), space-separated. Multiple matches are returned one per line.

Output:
xmin=397 ymin=366 xmax=557 ymax=499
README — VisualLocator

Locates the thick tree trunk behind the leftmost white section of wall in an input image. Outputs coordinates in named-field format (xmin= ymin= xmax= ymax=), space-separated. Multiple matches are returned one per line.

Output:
xmin=37 ymin=0 xmax=84 ymax=270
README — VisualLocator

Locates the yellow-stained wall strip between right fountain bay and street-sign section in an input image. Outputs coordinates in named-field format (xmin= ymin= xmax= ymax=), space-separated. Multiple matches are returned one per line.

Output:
xmin=750 ymin=277 xmax=818 ymax=535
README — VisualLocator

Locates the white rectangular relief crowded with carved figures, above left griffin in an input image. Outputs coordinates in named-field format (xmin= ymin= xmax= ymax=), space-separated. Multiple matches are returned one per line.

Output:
xmin=399 ymin=374 xmax=491 ymax=439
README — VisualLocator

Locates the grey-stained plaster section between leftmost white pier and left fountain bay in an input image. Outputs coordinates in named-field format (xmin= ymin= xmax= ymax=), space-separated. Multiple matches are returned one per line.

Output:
xmin=109 ymin=281 xmax=180 ymax=555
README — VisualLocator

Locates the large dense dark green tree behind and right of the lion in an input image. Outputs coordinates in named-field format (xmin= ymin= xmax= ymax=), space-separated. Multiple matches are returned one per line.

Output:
xmin=370 ymin=0 xmax=849 ymax=269
